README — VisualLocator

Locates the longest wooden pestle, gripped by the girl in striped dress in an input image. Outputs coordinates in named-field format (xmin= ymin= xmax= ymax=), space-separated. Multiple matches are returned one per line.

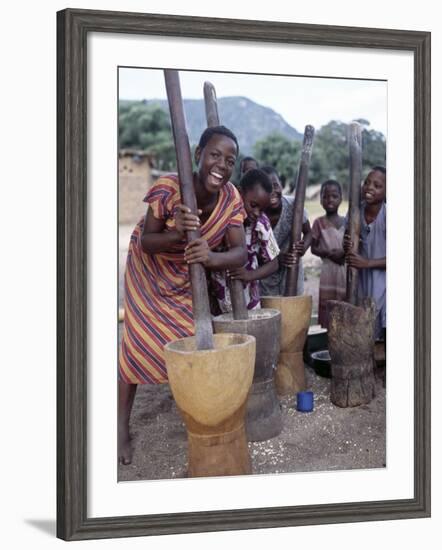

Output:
xmin=164 ymin=70 xmax=213 ymax=349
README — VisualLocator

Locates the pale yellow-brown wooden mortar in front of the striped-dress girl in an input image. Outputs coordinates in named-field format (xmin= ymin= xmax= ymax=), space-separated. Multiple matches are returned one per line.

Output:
xmin=164 ymin=334 xmax=256 ymax=477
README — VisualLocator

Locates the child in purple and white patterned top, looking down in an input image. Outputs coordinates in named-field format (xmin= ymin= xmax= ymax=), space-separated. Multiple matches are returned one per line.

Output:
xmin=212 ymin=169 xmax=279 ymax=313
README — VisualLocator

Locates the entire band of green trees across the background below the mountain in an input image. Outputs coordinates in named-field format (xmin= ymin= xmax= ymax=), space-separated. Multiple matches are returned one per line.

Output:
xmin=119 ymin=100 xmax=386 ymax=192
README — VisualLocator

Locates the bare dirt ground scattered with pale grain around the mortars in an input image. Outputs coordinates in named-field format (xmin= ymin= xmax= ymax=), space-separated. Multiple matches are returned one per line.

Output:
xmin=118 ymin=226 xmax=386 ymax=481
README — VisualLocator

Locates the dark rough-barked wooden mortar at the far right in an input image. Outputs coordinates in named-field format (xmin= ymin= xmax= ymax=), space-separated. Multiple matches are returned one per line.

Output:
xmin=328 ymin=299 xmax=376 ymax=407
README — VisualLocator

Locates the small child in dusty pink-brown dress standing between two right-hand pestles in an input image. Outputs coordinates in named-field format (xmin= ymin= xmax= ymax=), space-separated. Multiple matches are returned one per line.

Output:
xmin=312 ymin=180 xmax=346 ymax=328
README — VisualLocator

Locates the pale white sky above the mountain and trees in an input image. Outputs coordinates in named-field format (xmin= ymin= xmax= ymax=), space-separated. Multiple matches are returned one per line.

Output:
xmin=119 ymin=68 xmax=387 ymax=136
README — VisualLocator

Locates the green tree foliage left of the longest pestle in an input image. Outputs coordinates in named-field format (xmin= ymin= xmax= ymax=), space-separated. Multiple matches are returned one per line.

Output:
xmin=118 ymin=101 xmax=176 ymax=171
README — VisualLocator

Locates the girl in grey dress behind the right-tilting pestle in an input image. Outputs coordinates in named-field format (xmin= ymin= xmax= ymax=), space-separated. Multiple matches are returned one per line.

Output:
xmin=260 ymin=166 xmax=312 ymax=296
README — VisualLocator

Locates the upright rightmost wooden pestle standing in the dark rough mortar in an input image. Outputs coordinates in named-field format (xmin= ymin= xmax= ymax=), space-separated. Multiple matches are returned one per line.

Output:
xmin=346 ymin=122 xmax=362 ymax=305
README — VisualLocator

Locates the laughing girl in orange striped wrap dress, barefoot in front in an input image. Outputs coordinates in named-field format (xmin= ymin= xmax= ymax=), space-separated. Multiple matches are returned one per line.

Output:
xmin=118 ymin=126 xmax=247 ymax=464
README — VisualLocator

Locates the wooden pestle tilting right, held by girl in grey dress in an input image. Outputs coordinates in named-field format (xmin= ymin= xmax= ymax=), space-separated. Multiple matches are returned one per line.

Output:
xmin=284 ymin=125 xmax=315 ymax=296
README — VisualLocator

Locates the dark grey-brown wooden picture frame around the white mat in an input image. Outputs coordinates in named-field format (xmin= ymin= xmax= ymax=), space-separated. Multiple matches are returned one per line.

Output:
xmin=57 ymin=9 xmax=430 ymax=540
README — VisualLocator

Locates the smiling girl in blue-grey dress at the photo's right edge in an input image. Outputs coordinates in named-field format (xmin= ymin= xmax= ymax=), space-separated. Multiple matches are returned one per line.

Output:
xmin=344 ymin=166 xmax=387 ymax=340
